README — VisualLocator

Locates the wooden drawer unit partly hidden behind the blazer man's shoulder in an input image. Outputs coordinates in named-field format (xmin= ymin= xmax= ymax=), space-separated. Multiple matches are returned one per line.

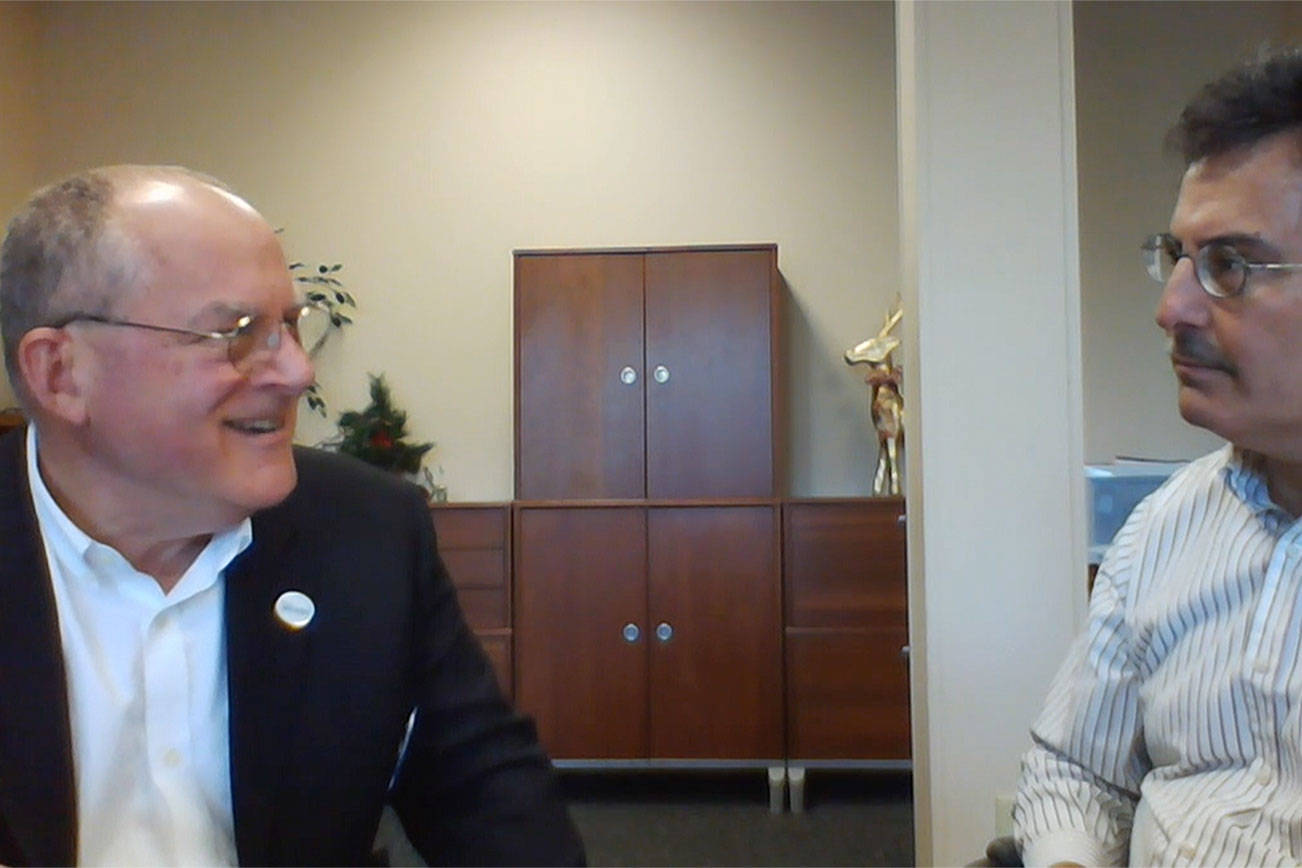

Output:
xmin=430 ymin=504 xmax=514 ymax=696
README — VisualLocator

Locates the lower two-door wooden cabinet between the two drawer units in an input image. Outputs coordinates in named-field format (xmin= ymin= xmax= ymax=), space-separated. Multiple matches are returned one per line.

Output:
xmin=516 ymin=504 xmax=783 ymax=760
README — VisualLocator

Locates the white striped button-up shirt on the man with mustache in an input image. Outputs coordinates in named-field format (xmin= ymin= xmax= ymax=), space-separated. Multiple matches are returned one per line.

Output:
xmin=1013 ymin=445 xmax=1302 ymax=865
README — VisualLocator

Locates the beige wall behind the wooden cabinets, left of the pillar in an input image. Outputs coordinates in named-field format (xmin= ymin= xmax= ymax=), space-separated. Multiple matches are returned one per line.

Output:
xmin=17 ymin=3 xmax=897 ymax=500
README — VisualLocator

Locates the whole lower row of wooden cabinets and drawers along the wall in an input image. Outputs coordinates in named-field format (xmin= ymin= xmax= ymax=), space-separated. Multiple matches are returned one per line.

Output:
xmin=432 ymin=497 xmax=910 ymax=804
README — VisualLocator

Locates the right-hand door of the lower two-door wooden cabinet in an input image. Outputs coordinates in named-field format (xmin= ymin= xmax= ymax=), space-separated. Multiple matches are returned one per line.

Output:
xmin=647 ymin=506 xmax=783 ymax=759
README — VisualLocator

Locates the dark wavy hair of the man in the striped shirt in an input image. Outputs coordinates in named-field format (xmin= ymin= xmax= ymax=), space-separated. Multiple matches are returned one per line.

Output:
xmin=1167 ymin=48 xmax=1302 ymax=163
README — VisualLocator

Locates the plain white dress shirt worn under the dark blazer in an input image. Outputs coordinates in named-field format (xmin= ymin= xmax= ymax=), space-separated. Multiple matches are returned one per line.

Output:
xmin=27 ymin=426 xmax=253 ymax=865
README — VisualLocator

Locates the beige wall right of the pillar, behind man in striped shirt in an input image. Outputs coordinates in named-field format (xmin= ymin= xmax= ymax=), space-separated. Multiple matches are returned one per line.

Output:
xmin=1074 ymin=3 xmax=1302 ymax=462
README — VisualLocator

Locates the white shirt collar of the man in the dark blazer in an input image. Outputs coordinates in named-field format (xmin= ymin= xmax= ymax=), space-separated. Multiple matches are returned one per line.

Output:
xmin=27 ymin=424 xmax=253 ymax=599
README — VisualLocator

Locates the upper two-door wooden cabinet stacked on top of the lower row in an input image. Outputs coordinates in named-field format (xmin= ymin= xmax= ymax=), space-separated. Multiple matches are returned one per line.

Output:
xmin=516 ymin=245 xmax=781 ymax=500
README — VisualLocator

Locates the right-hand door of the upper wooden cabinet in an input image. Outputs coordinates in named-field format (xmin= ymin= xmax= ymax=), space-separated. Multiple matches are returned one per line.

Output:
xmin=646 ymin=249 xmax=775 ymax=497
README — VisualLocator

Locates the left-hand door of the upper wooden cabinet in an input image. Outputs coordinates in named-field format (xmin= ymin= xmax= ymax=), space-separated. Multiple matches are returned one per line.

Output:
xmin=516 ymin=254 xmax=646 ymax=500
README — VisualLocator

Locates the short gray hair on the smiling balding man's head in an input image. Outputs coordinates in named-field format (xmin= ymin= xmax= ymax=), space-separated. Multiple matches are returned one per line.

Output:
xmin=0 ymin=165 xmax=227 ymax=406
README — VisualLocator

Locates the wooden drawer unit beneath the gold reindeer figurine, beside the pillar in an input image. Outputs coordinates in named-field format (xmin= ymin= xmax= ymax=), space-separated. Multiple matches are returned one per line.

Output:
xmin=783 ymin=497 xmax=910 ymax=763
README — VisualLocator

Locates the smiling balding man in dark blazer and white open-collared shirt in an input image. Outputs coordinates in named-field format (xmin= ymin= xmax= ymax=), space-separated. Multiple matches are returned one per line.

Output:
xmin=0 ymin=165 xmax=583 ymax=865
